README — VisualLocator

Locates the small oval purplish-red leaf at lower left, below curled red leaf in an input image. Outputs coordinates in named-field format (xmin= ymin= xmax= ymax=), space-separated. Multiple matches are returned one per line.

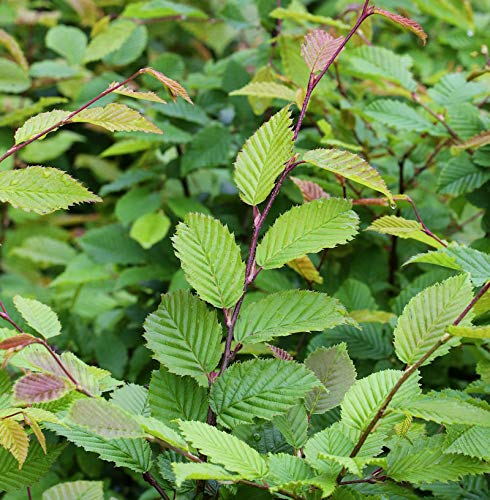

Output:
xmin=14 ymin=373 xmax=73 ymax=403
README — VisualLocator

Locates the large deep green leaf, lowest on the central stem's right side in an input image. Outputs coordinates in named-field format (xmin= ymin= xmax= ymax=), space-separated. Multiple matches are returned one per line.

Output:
xmin=210 ymin=359 xmax=320 ymax=427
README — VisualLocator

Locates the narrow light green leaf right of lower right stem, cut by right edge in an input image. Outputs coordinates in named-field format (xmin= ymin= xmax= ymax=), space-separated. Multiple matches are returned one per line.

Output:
xmin=392 ymin=393 xmax=490 ymax=427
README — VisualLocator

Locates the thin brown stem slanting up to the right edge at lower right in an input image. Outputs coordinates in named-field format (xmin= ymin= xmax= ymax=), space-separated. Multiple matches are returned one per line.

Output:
xmin=337 ymin=281 xmax=490 ymax=482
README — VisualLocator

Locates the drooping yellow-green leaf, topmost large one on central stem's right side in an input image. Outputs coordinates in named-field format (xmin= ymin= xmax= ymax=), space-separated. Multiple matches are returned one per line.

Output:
xmin=303 ymin=149 xmax=395 ymax=205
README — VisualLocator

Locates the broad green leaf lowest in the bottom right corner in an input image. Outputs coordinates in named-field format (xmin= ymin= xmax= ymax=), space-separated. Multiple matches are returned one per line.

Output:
xmin=386 ymin=435 xmax=490 ymax=485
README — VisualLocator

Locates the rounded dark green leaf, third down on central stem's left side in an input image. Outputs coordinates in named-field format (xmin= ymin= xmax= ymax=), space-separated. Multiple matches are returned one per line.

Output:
xmin=144 ymin=290 xmax=222 ymax=385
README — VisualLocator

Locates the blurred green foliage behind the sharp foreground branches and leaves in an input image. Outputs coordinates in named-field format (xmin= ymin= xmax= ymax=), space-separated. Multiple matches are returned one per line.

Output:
xmin=0 ymin=0 xmax=490 ymax=499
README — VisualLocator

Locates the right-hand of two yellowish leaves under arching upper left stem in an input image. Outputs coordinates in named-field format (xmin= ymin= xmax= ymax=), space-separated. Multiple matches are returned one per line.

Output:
xmin=71 ymin=102 xmax=163 ymax=134
